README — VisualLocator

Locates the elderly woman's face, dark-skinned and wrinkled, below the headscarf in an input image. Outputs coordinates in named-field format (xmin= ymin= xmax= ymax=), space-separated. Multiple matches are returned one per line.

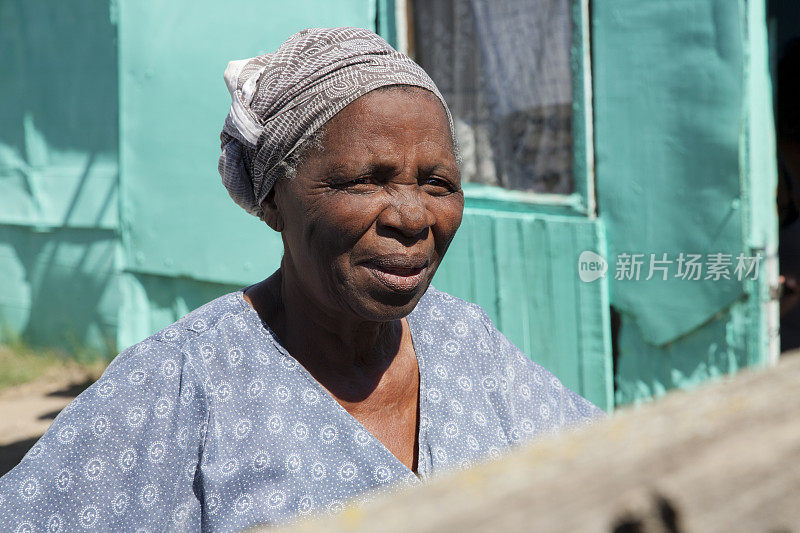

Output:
xmin=264 ymin=88 xmax=464 ymax=321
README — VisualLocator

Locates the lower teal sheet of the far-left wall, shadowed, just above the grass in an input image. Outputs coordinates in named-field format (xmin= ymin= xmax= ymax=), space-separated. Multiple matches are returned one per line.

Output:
xmin=0 ymin=226 xmax=120 ymax=358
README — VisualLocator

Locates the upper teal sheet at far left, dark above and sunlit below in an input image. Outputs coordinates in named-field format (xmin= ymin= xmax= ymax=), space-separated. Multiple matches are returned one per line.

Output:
xmin=0 ymin=0 xmax=118 ymax=229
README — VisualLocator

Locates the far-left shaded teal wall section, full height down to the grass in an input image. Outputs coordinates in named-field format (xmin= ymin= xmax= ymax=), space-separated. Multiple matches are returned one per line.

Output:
xmin=0 ymin=0 xmax=119 ymax=357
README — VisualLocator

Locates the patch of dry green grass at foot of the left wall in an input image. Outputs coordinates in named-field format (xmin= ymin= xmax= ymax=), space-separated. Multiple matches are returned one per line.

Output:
xmin=0 ymin=344 xmax=108 ymax=391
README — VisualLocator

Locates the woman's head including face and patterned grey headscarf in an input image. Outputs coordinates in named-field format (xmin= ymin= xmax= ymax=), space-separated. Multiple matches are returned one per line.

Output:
xmin=220 ymin=28 xmax=464 ymax=321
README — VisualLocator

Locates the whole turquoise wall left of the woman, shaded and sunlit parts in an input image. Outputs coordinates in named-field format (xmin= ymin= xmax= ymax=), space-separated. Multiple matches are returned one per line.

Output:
xmin=0 ymin=0 xmax=377 ymax=357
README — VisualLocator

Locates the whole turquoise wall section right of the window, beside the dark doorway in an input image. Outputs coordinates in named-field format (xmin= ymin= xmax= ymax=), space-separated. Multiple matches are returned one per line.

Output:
xmin=592 ymin=0 xmax=777 ymax=402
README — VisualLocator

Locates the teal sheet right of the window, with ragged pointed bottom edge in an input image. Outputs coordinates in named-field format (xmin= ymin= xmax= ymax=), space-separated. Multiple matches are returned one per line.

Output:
xmin=592 ymin=0 xmax=752 ymax=345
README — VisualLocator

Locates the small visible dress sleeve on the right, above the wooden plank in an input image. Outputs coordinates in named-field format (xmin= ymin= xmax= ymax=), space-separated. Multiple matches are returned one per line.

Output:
xmin=478 ymin=308 xmax=606 ymax=443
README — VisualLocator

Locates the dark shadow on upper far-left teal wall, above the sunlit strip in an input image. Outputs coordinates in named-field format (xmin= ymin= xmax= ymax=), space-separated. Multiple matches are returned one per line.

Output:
xmin=0 ymin=0 xmax=118 ymax=158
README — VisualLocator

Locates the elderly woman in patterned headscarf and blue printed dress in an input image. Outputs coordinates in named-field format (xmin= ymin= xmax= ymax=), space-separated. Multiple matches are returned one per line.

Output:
xmin=0 ymin=28 xmax=600 ymax=531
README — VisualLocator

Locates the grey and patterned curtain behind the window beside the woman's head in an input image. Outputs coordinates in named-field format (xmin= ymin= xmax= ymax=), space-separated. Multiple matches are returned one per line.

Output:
xmin=413 ymin=0 xmax=573 ymax=194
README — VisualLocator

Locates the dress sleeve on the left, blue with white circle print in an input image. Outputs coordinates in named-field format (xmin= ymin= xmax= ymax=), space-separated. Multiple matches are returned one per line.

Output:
xmin=0 ymin=340 xmax=207 ymax=531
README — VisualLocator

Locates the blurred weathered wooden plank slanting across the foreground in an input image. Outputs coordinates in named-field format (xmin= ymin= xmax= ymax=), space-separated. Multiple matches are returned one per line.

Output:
xmin=274 ymin=355 xmax=800 ymax=533
